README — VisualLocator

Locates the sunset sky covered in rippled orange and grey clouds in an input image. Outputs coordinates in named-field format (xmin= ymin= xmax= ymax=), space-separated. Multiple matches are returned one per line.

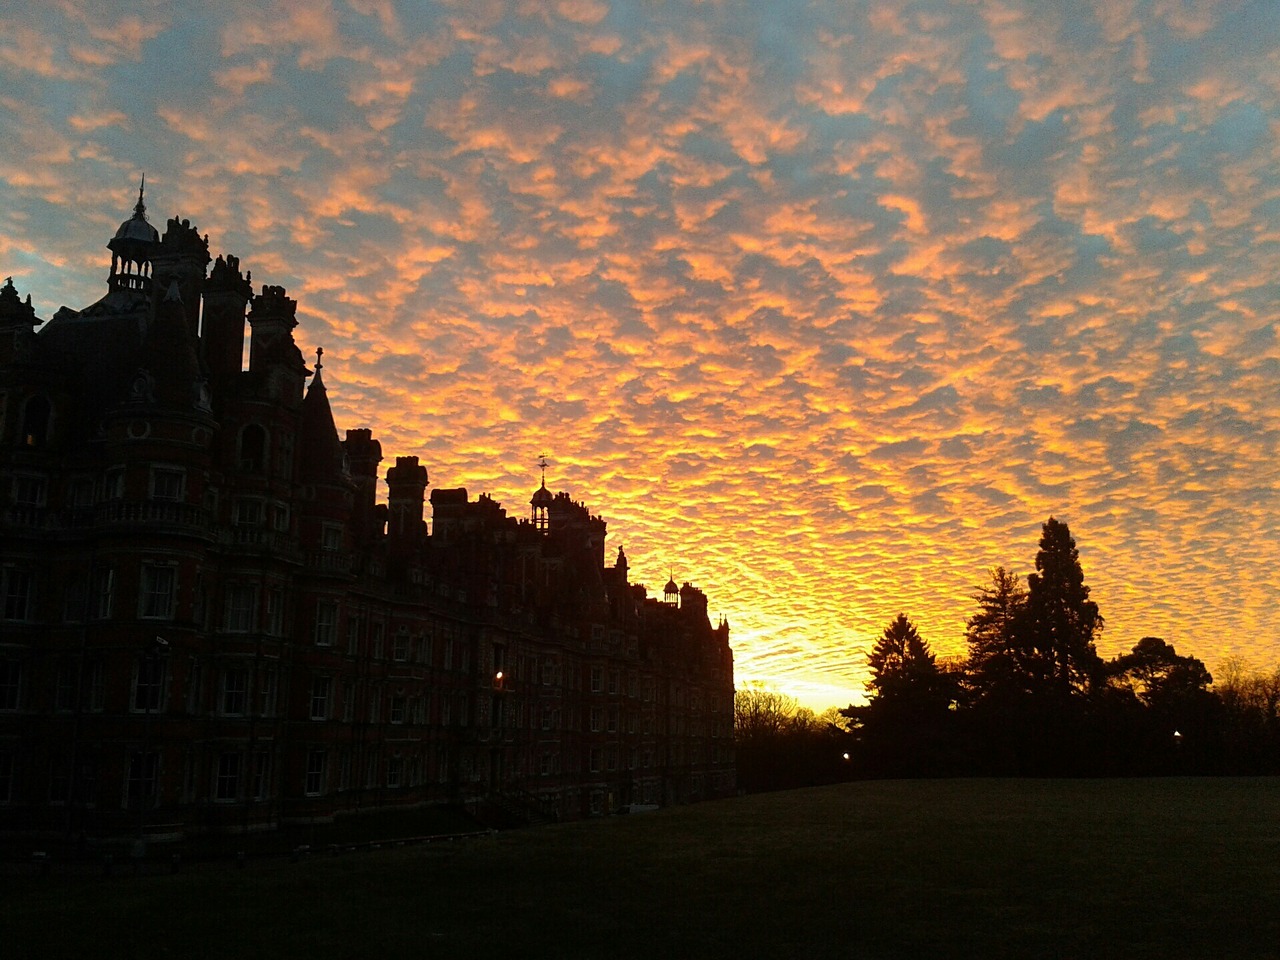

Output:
xmin=0 ymin=0 xmax=1280 ymax=709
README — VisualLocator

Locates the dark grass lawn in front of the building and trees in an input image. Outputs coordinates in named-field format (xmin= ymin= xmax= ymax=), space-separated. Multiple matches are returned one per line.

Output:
xmin=0 ymin=780 xmax=1280 ymax=960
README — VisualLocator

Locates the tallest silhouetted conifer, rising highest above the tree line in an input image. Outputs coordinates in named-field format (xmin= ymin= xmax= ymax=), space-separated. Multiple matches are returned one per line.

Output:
xmin=1014 ymin=517 xmax=1102 ymax=698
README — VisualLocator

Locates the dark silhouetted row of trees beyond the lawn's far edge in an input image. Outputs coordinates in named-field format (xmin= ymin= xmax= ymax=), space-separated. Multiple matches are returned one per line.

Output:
xmin=735 ymin=517 xmax=1280 ymax=790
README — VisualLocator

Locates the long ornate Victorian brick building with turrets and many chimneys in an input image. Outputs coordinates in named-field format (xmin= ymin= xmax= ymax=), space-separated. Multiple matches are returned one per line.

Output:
xmin=0 ymin=192 xmax=735 ymax=837
